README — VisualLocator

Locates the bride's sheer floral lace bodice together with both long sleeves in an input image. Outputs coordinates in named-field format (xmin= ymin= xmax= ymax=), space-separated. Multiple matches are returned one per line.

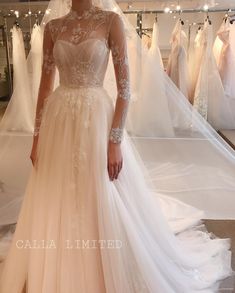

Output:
xmin=35 ymin=6 xmax=130 ymax=143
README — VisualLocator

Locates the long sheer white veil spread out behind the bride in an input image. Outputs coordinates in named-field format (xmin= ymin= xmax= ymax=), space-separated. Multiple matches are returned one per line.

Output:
xmin=0 ymin=0 xmax=235 ymax=242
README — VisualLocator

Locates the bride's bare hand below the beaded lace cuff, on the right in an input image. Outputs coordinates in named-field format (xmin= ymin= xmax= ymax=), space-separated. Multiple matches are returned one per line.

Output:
xmin=108 ymin=141 xmax=123 ymax=181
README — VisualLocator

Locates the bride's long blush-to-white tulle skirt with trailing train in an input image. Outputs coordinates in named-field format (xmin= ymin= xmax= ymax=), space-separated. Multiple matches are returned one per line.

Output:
xmin=0 ymin=85 xmax=231 ymax=293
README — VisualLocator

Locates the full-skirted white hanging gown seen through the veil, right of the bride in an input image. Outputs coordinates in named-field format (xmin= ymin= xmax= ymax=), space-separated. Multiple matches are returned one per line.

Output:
xmin=127 ymin=23 xmax=175 ymax=137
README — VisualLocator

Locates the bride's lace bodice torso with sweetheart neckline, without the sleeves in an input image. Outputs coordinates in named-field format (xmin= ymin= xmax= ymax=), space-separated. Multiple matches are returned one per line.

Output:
xmin=47 ymin=10 xmax=115 ymax=87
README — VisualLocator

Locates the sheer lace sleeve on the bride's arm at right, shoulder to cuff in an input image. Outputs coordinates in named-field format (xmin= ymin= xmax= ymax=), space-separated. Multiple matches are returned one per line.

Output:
xmin=109 ymin=14 xmax=130 ymax=143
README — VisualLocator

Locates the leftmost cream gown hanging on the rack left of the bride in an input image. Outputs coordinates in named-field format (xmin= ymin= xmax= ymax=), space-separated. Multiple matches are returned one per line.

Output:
xmin=0 ymin=26 xmax=34 ymax=131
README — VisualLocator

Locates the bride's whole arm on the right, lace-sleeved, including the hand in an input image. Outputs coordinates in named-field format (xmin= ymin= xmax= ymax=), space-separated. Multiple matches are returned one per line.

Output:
xmin=108 ymin=14 xmax=130 ymax=180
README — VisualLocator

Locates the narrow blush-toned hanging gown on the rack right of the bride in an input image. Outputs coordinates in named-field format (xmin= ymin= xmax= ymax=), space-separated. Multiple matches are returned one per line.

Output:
xmin=167 ymin=19 xmax=190 ymax=98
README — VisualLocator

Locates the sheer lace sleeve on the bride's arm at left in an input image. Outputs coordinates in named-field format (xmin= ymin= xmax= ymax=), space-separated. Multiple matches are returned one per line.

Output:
xmin=34 ymin=22 xmax=55 ymax=136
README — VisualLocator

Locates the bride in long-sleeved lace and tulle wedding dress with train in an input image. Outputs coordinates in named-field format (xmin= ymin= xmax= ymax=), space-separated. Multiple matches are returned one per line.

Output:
xmin=0 ymin=0 xmax=231 ymax=293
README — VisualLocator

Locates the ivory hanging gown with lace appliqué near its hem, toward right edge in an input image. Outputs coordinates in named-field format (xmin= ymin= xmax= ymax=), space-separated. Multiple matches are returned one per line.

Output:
xmin=194 ymin=21 xmax=235 ymax=130
